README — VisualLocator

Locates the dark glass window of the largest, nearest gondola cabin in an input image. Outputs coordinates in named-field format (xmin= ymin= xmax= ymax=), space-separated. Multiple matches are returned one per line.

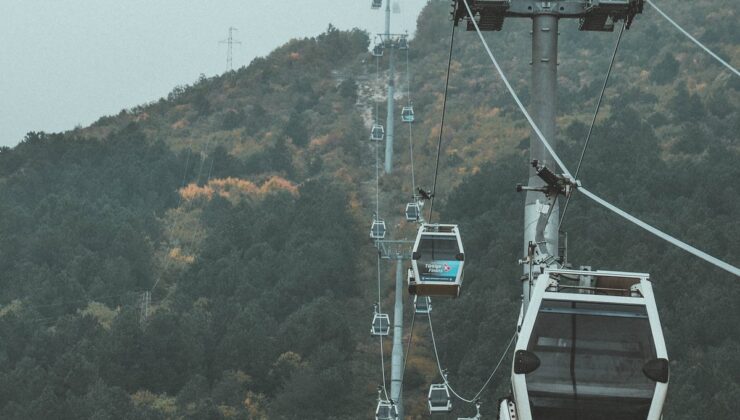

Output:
xmin=526 ymin=300 xmax=656 ymax=420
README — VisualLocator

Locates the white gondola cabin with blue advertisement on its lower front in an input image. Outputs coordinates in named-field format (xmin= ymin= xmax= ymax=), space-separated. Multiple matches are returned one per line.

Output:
xmin=409 ymin=223 xmax=465 ymax=297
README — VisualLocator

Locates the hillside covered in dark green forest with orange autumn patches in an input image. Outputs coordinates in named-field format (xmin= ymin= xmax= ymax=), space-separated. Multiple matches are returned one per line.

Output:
xmin=0 ymin=0 xmax=740 ymax=419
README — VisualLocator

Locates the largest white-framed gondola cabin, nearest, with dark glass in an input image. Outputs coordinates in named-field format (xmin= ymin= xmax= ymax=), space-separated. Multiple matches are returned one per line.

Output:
xmin=506 ymin=269 xmax=669 ymax=420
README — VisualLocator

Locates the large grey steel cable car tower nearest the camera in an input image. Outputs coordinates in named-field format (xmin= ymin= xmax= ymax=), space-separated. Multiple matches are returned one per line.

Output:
xmin=452 ymin=0 xmax=643 ymax=280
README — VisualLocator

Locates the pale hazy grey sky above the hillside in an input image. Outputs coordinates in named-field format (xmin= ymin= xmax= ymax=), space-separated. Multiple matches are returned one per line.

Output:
xmin=0 ymin=0 xmax=427 ymax=146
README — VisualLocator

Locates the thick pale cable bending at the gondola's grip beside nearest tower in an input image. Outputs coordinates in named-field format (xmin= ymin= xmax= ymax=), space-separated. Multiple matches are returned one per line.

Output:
xmin=463 ymin=0 xmax=740 ymax=277
